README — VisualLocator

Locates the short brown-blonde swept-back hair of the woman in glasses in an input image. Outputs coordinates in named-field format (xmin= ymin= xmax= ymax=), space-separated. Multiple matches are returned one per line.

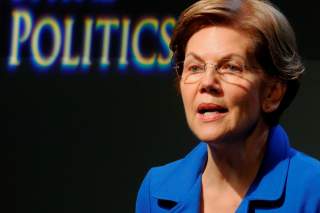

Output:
xmin=170 ymin=0 xmax=305 ymax=126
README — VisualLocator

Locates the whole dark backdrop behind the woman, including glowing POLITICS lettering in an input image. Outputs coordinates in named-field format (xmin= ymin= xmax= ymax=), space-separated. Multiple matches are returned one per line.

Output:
xmin=0 ymin=0 xmax=320 ymax=213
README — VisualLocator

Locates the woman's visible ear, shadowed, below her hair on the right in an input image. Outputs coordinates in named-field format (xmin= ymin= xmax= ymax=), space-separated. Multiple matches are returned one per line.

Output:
xmin=262 ymin=80 xmax=287 ymax=113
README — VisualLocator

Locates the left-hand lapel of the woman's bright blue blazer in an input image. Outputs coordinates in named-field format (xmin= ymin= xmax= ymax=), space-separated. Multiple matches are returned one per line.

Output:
xmin=150 ymin=143 xmax=207 ymax=212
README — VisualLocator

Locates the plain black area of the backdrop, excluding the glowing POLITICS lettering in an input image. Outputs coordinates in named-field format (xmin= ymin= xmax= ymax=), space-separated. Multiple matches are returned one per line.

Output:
xmin=0 ymin=0 xmax=320 ymax=213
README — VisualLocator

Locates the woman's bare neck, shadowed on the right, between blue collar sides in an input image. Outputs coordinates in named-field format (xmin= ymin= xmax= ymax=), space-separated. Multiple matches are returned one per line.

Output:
xmin=202 ymin=120 xmax=269 ymax=198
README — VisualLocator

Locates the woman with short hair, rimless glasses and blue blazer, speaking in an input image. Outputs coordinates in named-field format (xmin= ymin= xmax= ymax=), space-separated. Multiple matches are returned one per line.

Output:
xmin=136 ymin=0 xmax=320 ymax=213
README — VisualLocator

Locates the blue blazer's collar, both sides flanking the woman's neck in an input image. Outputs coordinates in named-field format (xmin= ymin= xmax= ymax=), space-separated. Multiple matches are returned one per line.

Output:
xmin=151 ymin=125 xmax=290 ymax=203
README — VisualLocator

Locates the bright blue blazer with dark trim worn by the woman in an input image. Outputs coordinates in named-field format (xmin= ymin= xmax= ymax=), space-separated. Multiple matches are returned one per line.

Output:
xmin=136 ymin=126 xmax=320 ymax=213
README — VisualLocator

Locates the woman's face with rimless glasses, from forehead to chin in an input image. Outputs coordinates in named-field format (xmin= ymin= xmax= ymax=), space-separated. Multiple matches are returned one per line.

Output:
xmin=180 ymin=26 xmax=266 ymax=143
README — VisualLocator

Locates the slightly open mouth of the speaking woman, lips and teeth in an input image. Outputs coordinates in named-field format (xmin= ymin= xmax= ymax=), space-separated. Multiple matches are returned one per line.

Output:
xmin=197 ymin=103 xmax=228 ymax=121
